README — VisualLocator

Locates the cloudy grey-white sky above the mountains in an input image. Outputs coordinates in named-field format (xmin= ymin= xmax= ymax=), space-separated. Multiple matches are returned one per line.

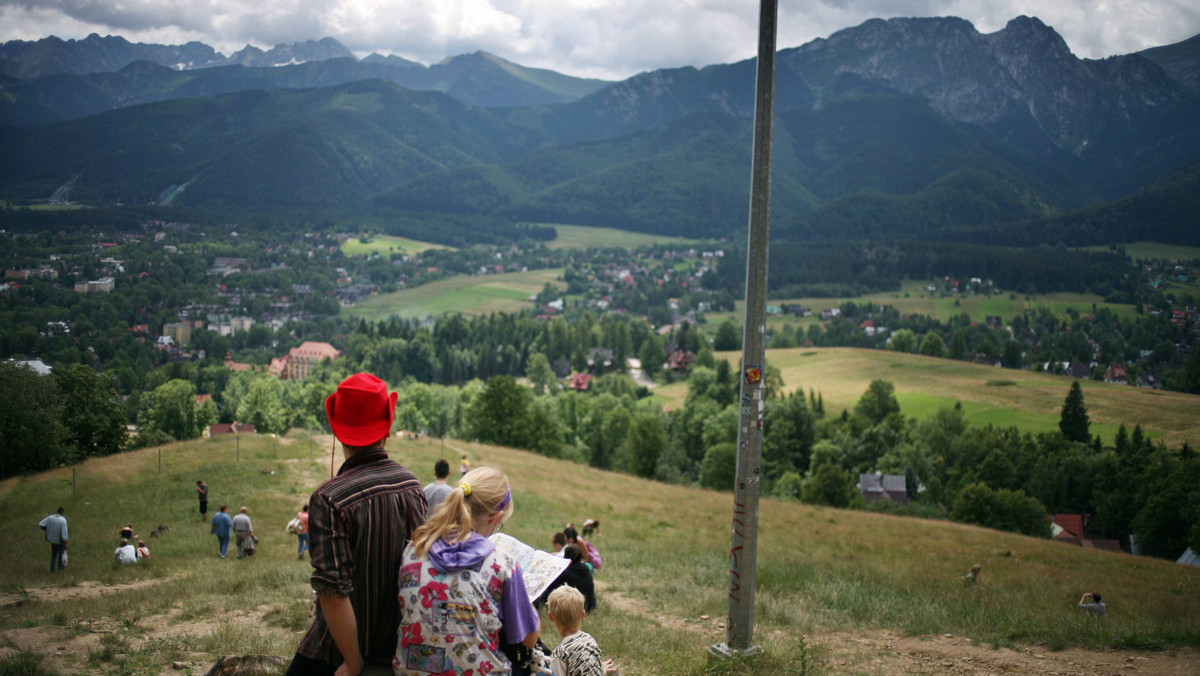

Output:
xmin=0 ymin=0 xmax=1200 ymax=79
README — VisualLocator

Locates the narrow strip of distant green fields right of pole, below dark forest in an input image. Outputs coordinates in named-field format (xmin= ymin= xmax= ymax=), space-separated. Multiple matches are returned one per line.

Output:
xmin=706 ymin=280 xmax=1136 ymax=333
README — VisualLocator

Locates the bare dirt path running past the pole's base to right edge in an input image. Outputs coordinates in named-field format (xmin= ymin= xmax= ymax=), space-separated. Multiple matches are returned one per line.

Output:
xmin=596 ymin=580 xmax=1200 ymax=676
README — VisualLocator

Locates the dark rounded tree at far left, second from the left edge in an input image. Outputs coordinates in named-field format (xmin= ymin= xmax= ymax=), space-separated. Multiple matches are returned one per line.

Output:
xmin=52 ymin=364 xmax=128 ymax=457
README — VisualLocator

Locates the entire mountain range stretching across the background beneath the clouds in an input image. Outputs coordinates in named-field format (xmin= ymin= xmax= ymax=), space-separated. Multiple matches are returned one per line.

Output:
xmin=0 ymin=17 xmax=1200 ymax=246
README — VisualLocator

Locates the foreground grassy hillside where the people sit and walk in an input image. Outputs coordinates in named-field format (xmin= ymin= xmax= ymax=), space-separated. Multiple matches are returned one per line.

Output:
xmin=0 ymin=432 xmax=1200 ymax=676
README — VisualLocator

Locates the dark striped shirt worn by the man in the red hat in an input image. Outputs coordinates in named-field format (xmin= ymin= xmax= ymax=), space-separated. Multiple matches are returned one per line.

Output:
xmin=296 ymin=450 xmax=425 ymax=666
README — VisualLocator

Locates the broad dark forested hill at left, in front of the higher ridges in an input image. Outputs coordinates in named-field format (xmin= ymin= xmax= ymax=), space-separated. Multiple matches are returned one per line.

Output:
xmin=0 ymin=80 xmax=517 ymax=205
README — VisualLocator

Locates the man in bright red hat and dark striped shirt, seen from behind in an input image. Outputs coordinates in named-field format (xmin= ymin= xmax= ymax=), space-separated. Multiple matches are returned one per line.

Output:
xmin=287 ymin=373 xmax=426 ymax=676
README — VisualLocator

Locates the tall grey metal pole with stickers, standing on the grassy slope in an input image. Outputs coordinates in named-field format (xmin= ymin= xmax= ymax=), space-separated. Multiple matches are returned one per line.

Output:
xmin=709 ymin=0 xmax=778 ymax=659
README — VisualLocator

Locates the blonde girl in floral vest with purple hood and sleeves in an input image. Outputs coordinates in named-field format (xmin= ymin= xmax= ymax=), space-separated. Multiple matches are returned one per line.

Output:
xmin=392 ymin=467 xmax=538 ymax=676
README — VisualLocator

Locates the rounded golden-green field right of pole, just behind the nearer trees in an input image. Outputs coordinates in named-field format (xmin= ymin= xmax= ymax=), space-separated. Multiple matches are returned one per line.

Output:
xmin=654 ymin=347 xmax=1200 ymax=447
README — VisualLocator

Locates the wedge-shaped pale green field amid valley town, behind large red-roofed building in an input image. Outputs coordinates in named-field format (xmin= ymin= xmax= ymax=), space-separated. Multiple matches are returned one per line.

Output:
xmin=342 ymin=268 xmax=563 ymax=322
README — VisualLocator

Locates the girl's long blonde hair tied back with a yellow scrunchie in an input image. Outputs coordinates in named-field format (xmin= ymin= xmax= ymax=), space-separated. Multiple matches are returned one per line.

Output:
xmin=413 ymin=467 xmax=512 ymax=557
